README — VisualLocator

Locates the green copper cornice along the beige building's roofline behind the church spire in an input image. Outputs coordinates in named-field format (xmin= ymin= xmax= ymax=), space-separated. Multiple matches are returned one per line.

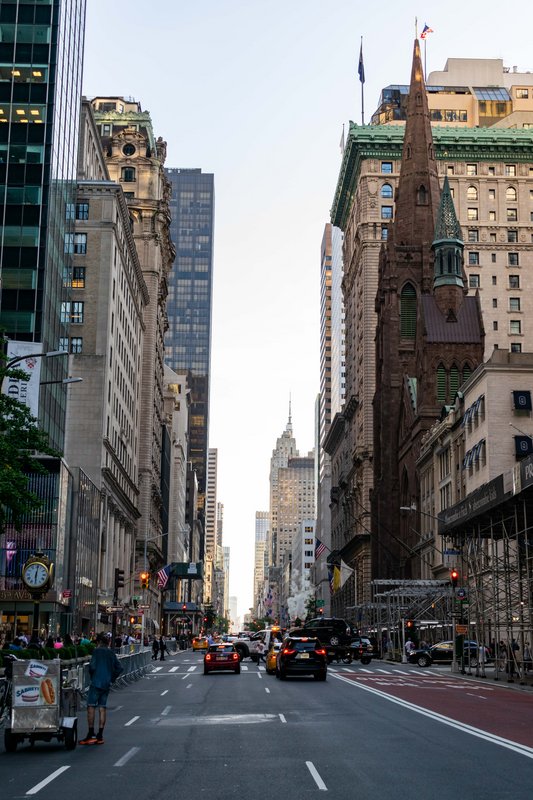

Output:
xmin=331 ymin=122 xmax=533 ymax=230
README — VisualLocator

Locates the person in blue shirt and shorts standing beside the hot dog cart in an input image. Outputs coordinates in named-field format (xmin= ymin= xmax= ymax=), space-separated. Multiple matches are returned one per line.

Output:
xmin=80 ymin=633 xmax=124 ymax=744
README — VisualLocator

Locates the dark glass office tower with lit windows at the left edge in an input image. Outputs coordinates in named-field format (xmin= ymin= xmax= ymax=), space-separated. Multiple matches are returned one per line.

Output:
xmin=0 ymin=0 xmax=85 ymax=449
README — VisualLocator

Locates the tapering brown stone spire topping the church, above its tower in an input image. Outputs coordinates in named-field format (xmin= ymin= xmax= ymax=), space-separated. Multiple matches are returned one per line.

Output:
xmin=393 ymin=39 xmax=440 ymax=248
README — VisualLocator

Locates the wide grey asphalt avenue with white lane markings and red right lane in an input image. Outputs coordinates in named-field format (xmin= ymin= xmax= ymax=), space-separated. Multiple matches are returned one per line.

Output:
xmin=0 ymin=651 xmax=533 ymax=800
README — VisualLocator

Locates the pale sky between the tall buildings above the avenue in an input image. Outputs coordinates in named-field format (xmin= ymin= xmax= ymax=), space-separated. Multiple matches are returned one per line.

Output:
xmin=84 ymin=0 xmax=533 ymax=615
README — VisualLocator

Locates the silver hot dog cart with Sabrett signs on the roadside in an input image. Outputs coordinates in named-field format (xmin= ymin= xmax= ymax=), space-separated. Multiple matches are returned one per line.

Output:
xmin=4 ymin=659 xmax=78 ymax=753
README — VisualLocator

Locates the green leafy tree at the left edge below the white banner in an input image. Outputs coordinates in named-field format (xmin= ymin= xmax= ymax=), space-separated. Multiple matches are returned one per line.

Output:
xmin=0 ymin=348 xmax=60 ymax=531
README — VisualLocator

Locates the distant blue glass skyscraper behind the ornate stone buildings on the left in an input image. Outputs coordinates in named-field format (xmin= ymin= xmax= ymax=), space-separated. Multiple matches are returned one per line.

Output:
xmin=165 ymin=169 xmax=215 ymax=494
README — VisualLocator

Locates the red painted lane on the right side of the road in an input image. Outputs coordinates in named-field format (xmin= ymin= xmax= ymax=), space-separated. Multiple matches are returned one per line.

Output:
xmin=339 ymin=670 xmax=533 ymax=748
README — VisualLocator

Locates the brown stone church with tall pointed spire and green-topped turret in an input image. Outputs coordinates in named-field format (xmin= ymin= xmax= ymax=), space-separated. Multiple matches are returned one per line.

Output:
xmin=372 ymin=40 xmax=483 ymax=579
